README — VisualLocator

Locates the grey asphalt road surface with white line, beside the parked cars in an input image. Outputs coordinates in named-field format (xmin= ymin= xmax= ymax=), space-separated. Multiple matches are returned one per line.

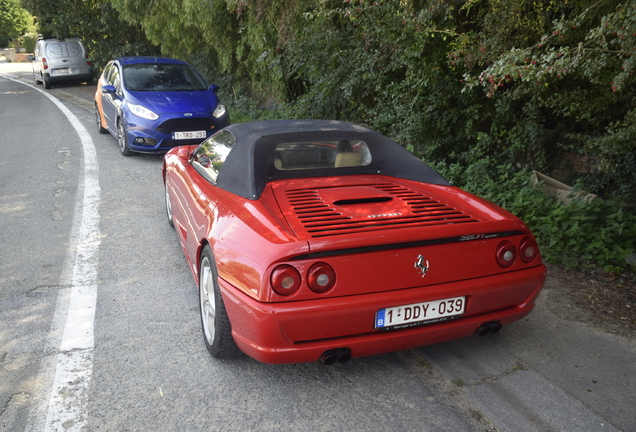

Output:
xmin=0 ymin=61 xmax=636 ymax=432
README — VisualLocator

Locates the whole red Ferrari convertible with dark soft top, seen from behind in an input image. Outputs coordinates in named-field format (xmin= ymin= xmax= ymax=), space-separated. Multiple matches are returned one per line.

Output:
xmin=163 ymin=120 xmax=546 ymax=364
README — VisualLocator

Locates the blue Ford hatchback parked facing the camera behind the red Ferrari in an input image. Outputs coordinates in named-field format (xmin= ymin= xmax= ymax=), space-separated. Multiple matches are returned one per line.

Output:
xmin=95 ymin=57 xmax=230 ymax=156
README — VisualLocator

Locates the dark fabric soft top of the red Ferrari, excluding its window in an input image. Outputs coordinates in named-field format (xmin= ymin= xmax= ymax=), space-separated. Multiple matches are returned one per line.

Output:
xmin=216 ymin=120 xmax=450 ymax=200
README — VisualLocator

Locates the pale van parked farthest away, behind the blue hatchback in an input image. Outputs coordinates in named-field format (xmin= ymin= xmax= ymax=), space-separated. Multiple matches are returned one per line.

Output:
xmin=31 ymin=39 xmax=93 ymax=89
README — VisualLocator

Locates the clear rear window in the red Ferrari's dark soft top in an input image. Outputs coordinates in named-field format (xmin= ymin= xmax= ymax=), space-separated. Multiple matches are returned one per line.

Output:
xmin=274 ymin=140 xmax=371 ymax=171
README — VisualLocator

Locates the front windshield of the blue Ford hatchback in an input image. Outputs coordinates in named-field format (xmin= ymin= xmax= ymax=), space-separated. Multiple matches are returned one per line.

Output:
xmin=124 ymin=63 xmax=208 ymax=91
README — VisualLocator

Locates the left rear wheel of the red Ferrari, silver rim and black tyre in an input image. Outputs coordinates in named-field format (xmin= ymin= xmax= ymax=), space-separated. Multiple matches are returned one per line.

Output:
xmin=199 ymin=245 xmax=238 ymax=359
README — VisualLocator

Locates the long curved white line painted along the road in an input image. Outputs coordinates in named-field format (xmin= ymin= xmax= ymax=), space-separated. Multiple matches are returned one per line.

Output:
xmin=0 ymin=75 xmax=101 ymax=432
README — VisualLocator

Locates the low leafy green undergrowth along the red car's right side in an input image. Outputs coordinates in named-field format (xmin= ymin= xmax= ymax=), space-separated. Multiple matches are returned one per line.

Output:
xmin=433 ymin=156 xmax=636 ymax=272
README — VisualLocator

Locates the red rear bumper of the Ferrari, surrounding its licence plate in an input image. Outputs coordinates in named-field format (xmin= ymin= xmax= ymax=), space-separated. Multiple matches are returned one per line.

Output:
xmin=219 ymin=265 xmax=546 ymax=364
